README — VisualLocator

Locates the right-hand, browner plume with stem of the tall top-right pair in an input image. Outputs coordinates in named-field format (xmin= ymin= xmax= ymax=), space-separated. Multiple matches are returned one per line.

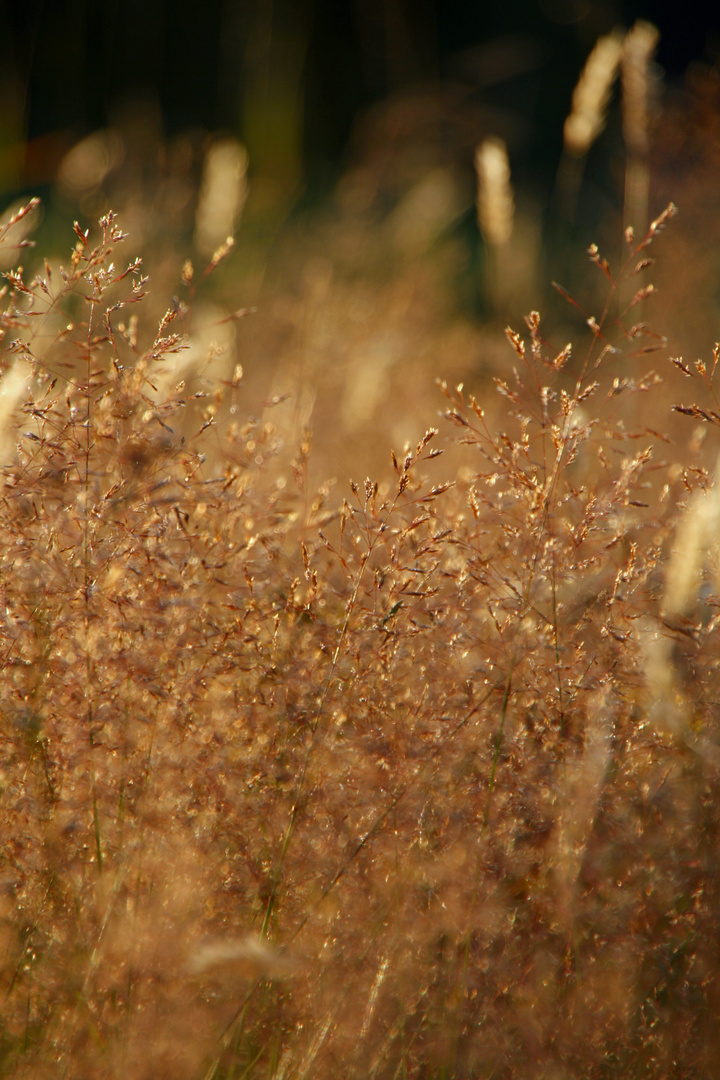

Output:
xmin=622 ymin=19 xmax=660 ymax=229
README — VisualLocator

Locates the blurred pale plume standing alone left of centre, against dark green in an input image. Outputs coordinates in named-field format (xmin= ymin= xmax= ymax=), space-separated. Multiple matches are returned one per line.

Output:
xmin=195 ymin=138 xmax=248 ymax=255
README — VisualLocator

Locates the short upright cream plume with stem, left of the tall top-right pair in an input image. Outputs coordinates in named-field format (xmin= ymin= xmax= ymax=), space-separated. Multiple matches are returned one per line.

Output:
xmin=475 ymin=135 xmax=515 ymax=311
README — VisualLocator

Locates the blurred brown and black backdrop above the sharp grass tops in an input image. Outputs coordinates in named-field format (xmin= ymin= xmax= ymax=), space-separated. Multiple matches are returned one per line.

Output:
xmin=0 ymin=0 xmax=720 ymax=474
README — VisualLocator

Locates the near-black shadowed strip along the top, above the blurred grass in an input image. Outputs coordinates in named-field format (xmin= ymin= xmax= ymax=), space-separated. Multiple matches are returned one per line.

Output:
xmin=0 ymin=0 xmax=720 ymax=203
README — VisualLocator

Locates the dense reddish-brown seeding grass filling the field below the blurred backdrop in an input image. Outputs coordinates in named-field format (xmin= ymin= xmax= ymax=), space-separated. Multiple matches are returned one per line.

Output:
xmin=0 ymin=31 xmax=720 ymax=1080
